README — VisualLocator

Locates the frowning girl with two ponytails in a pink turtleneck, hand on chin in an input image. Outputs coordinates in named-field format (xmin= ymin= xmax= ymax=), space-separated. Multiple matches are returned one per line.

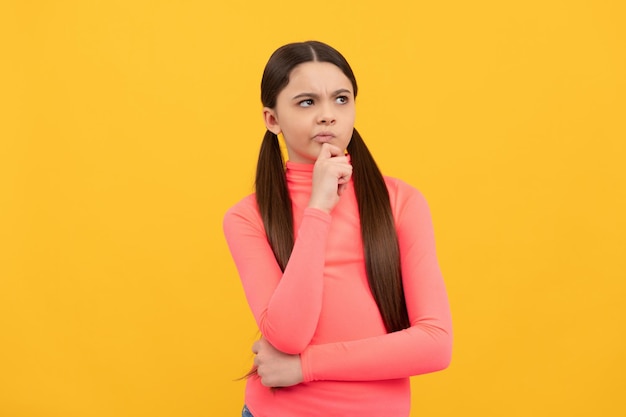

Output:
xmin=224 ymin=42 xmax=452 ymax=417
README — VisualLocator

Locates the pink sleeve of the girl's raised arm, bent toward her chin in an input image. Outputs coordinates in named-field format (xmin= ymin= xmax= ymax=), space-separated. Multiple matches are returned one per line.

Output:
xmin=223 ymin=196 xmax=330 ymax=354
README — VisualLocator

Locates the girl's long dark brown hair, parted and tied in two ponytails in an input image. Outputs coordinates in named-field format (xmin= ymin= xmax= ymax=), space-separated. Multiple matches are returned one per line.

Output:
xmin=256 ymin=41 xmax=410 ymax=333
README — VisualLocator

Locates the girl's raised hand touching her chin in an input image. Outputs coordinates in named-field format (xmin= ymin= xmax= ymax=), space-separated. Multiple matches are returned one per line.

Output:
xmin=309 ymin=143 xmax=352 ymax=213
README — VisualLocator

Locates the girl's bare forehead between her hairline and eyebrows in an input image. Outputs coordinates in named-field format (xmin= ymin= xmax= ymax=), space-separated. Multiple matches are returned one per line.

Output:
xmin=285 ymin=62 xmax=353 ymax=92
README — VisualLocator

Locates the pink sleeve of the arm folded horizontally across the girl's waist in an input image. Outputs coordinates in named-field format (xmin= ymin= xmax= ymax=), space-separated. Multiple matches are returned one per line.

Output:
xmin=301 ymin=180 xmax=452 ymax=382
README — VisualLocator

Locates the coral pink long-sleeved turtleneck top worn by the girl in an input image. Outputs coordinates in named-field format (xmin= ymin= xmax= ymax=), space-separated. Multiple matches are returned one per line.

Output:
xmin=224 ymin=162 xmax=452 ymax=417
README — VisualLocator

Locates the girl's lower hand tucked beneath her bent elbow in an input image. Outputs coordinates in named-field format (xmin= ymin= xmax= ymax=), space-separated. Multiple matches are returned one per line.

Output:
xmin=252 ymin=338 xmax=304 ymax=387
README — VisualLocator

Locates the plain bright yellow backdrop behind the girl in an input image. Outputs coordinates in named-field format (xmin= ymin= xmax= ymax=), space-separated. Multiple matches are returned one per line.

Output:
xmin=0 ymin=0 xmax=626 ymax=417
